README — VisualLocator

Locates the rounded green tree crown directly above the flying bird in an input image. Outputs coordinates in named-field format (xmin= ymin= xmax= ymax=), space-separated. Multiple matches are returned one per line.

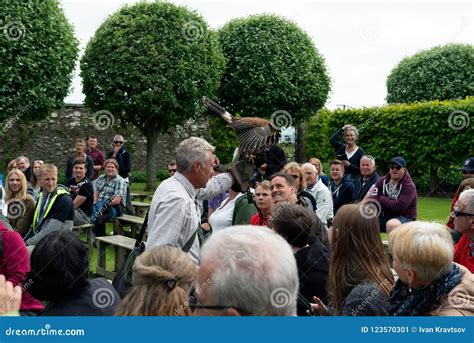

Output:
xmin=219 ymin=15 xmax=330 ymax=124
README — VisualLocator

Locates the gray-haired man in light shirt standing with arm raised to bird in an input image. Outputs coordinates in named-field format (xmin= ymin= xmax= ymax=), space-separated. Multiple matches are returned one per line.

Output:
xmin=146 ymin=137 xmax=234 ymax=262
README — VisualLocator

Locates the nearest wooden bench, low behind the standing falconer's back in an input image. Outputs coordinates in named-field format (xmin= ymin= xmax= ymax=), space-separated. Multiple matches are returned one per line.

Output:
xmin=96 ymin=235 xmax=135 ymax=280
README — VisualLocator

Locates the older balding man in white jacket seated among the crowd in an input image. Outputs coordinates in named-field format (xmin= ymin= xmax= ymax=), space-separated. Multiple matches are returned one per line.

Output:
xmin=303 ymin=163 xmax=334 ymax=229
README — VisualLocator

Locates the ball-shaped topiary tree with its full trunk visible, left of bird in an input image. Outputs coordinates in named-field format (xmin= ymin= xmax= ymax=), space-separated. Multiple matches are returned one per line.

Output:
xmin=81 ymin=2 xmax=225 ymax=190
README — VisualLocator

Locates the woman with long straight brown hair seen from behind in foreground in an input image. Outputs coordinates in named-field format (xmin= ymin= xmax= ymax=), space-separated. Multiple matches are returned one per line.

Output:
xmin=312 ymin=204 xmax=394 ymax=316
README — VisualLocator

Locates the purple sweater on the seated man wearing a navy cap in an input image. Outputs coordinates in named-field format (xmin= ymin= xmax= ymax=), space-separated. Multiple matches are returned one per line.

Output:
xmin=369 ymin=171 xmax=417 ymax=220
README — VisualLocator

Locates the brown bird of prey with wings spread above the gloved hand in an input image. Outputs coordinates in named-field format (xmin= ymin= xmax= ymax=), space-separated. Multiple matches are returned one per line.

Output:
xmin=202 ymin=96 xmax=280 ymax=159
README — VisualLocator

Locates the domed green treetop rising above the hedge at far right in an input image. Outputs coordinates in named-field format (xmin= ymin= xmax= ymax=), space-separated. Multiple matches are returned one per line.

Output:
xmin=387 ymin=44 xmax=474 ymax=103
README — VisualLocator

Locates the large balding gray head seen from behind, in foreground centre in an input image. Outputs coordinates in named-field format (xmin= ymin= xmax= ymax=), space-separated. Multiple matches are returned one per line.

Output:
xmin=190 ymin=225 xmax=299 ymax=316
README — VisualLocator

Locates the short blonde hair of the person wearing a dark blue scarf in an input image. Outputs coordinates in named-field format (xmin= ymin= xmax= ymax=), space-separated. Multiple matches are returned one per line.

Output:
xmin=388 ymin=221 xmax=454 ymax=284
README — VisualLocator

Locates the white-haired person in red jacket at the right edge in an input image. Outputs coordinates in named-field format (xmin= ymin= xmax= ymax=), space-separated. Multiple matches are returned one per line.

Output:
xmin=452 ymin=189 xmax=474 ymax=273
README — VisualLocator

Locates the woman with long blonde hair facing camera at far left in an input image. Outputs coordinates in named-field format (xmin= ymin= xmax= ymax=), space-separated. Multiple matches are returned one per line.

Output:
xmin=5 ymin=168 xmax=35 ymax=237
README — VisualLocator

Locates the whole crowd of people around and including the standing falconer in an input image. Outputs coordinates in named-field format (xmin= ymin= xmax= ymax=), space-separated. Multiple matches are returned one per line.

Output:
xmin=0 ymin=125 xmax=474 ymax=316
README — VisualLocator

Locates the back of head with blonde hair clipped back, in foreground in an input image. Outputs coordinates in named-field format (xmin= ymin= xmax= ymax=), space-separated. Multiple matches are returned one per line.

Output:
xmin=115 ymin=246 xmax=197 ymax=316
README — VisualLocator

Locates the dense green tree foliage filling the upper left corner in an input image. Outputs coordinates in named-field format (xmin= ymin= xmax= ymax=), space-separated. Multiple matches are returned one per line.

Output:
xmin=0 ymin=0 xmax=78 ymax=120
